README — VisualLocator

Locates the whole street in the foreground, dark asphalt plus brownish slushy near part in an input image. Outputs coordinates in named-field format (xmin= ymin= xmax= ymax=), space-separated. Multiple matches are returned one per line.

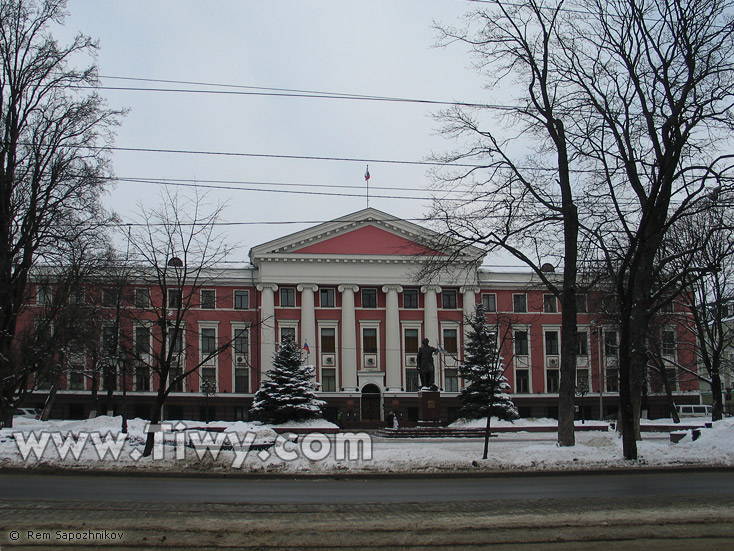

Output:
xmin=0 ymin=471 xmax=734 ymax=551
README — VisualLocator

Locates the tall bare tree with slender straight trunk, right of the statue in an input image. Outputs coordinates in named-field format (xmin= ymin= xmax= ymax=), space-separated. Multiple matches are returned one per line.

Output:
xmin=432 ymin=0 xmax=584 ymax=446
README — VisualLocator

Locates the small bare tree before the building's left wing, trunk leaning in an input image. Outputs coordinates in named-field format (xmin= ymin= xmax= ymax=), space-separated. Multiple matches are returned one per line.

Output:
xmin=122 ymin=193 xmax=236 ymax=456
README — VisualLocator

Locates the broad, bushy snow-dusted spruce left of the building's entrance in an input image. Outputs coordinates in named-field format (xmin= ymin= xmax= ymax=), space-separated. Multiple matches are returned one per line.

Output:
xmin=250 ymin=337 xmax=326 ymax=424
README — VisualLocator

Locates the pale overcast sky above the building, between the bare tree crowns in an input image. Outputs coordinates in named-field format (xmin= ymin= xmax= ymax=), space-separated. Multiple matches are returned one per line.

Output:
xmin=55 ymin=0 xmax=516 ymax=268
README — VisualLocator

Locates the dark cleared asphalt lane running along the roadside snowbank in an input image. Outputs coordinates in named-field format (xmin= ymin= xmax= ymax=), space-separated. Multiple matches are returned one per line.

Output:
xmin=0 ymin=470 xmax=734 ymax=504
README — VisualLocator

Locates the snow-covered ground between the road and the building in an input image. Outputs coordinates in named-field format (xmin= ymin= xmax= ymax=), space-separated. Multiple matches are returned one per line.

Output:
xmin=0 ymin=417 xmax=734 ymax=474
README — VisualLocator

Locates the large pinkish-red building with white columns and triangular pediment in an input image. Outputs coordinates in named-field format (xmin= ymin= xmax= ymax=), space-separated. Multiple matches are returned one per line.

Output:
xmin=21 ymin=208 xmax=699 ymax=426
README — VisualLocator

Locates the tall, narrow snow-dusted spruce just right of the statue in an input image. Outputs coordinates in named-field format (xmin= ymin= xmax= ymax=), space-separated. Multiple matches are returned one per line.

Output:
xmin=459 ymin=304 xmax=519 ymax=459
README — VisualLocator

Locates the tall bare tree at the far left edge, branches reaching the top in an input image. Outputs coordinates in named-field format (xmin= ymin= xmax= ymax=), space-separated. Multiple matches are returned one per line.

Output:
xmin=0 ymin=0 xmax=120 ymax=430
